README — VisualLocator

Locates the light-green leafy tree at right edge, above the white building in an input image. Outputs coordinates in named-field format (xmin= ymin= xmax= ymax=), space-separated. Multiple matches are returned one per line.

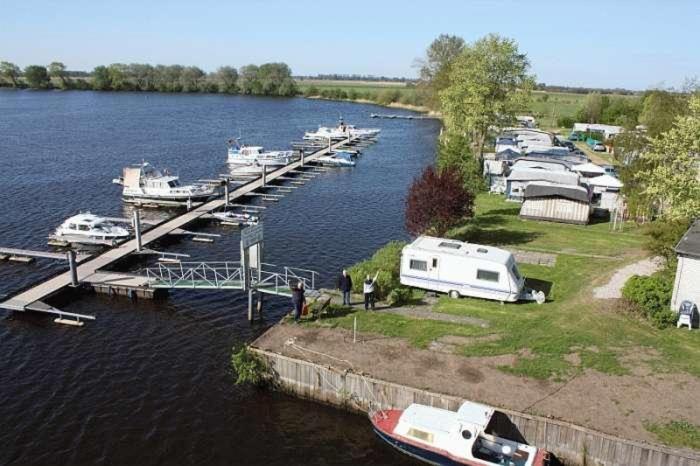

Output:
xmin=636 ymin=94 xmax=700 ymax=221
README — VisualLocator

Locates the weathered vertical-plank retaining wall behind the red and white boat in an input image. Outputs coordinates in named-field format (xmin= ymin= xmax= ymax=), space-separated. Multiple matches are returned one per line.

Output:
xmin=252 ymin=348 xmax=700 ymax=466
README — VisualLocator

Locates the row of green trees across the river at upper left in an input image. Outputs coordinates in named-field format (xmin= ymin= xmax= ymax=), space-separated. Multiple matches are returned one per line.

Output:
xmin=0 ymin=61 xmax=298 ymax=96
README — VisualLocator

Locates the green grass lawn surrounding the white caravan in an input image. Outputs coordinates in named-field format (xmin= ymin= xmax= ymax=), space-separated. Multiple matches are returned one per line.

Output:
xmin=317 ymin=194 xmax=700 ymax=380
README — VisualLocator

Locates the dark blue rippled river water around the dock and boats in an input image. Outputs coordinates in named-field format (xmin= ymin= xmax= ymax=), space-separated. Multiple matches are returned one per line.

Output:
xmin=0 ymin=90 xmax=439 ymax=465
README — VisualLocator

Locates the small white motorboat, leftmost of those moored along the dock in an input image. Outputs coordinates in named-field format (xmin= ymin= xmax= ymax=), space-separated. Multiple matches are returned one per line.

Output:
xmin=49 ymin=212 xmax=129 ymax=246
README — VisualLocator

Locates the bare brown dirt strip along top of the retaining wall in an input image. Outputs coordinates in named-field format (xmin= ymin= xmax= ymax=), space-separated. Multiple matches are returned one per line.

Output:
xmin=254 ymin=324 xmax=700 ymax=442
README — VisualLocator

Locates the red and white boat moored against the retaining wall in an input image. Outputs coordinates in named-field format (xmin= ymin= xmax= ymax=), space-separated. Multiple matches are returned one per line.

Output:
xmin=370 ymin=402 xmax=549 ymax=466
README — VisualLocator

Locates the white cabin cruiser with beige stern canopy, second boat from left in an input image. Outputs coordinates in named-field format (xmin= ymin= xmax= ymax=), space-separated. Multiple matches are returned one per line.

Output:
xmin=113 ymin=162 xmax=216 ymax=205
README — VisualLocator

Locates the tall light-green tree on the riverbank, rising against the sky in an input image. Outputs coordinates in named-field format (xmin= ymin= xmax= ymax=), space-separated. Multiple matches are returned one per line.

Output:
xmin=440 ymin=34 xmax=535 ymax=160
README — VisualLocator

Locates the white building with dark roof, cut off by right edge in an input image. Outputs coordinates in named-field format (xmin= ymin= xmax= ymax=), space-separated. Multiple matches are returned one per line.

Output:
xmin=671 ymin=219 xmax=700 ymax=312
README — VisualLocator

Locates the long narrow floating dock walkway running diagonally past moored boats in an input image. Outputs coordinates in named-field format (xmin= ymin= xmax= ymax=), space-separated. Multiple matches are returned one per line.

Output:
xmin=0 ymin=138 xmax=356 ymax=318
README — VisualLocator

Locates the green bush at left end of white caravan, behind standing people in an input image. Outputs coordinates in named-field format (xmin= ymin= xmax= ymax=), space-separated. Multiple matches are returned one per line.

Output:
xmin=348 ymin=241 xmax=406 ymax=300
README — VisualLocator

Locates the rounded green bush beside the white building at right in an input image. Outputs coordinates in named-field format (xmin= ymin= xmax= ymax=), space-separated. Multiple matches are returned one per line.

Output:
xmin=622 ymin=274 xmax=676 ymax=328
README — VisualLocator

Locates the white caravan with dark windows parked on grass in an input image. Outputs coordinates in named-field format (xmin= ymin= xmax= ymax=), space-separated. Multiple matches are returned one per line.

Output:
xmin=401 ymin=236 xmax=545 ymax=302
